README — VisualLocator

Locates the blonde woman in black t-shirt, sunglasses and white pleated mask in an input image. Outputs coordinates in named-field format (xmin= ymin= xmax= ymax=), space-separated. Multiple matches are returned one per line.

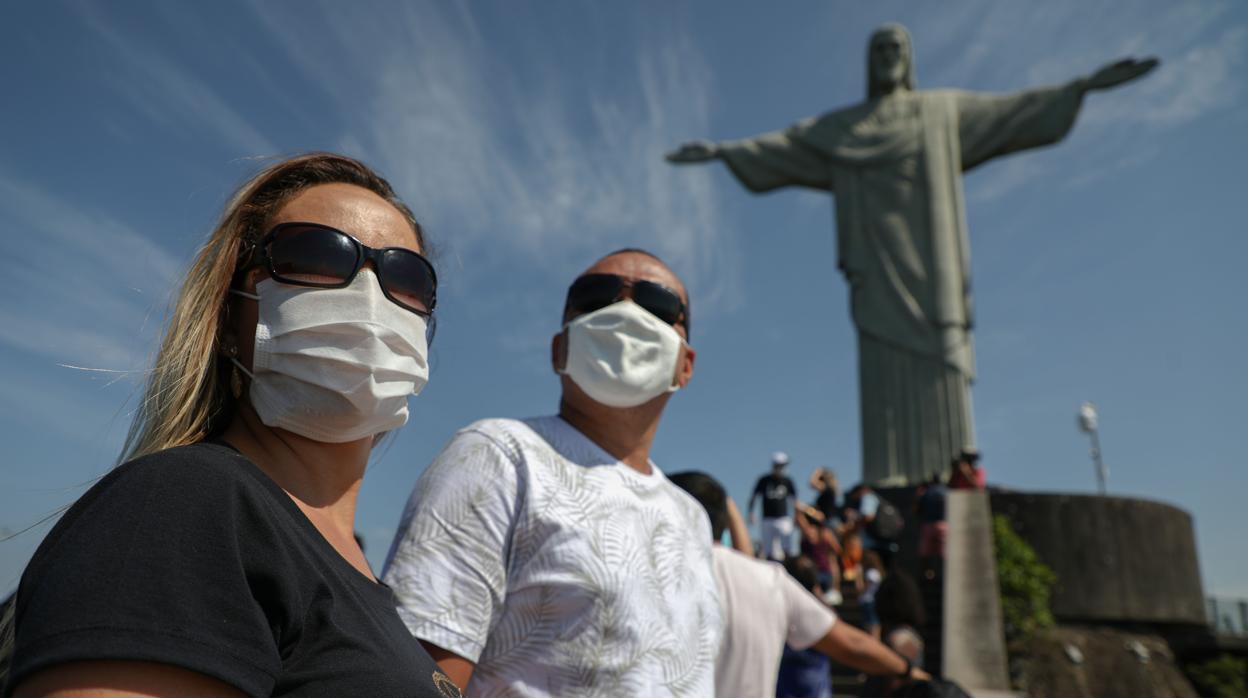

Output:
xmin=4 ymin=154 xmax=458 ymax=698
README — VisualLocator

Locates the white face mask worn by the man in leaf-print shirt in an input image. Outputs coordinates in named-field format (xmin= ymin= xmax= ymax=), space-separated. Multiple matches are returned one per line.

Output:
xmin=562 ymin=300 xmax=684 ymax=407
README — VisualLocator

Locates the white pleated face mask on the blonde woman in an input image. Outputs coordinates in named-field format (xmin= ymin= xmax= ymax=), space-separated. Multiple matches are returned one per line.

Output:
xmin=231 ymin=268 xmax=429 ymax=443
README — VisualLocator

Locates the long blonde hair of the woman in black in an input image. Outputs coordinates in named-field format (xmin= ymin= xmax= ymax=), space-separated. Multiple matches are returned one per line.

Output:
xmin=117 ymin=152 xmax=428 ymax=463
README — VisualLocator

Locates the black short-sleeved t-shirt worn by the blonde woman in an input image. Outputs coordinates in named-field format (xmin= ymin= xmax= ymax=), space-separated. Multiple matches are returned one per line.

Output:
xmin=4 ymin=442 xmax=459 ymax=698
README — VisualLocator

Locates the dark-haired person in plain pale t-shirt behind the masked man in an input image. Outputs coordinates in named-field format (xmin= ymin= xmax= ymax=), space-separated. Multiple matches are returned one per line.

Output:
xmin=671 ymin=472 xmax=931 ymax=698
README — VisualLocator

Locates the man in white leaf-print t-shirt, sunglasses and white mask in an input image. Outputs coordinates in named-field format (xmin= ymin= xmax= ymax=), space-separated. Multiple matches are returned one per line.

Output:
xmin=383 ymin=250 xmax=723 ymax=696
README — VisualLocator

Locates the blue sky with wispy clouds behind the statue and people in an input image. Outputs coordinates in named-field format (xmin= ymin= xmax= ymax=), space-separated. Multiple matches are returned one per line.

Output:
xmin=0 ymin=0 xmax=1248 ymax=597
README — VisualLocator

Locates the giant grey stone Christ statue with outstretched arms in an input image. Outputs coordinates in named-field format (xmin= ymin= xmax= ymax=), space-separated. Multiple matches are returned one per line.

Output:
xmin=666 ymin=25 xmax=1157 ymax=484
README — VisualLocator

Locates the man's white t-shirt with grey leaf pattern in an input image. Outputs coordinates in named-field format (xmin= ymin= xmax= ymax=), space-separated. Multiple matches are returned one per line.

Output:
xmin=383 ymin=417 xmax=723 ymax=697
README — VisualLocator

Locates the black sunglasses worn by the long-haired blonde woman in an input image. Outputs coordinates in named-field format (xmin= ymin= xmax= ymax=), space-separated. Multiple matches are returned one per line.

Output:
xmin=240 ymin=222 xmax=438 ymax=318
